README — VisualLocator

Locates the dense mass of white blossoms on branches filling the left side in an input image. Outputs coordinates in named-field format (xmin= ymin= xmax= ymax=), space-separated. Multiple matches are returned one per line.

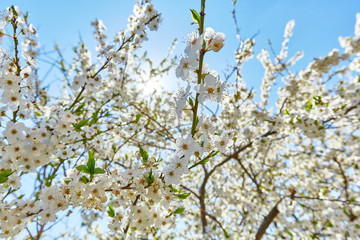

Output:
xmin=0 ymin=2 xmax=187 ymax=238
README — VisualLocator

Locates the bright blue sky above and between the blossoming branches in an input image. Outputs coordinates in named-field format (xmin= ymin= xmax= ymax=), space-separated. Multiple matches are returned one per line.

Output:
xmin=0 ymin=0 xmax=360 ymax=238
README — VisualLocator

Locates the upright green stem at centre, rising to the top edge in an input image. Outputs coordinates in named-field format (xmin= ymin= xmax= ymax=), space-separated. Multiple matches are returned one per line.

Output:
xmin=191 ymin=0 xmax=206 ymax=137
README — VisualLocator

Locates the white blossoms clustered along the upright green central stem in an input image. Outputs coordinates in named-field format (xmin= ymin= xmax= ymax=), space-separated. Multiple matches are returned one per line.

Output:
xmin=164 ymin=16 xmax=231 ymax=187
